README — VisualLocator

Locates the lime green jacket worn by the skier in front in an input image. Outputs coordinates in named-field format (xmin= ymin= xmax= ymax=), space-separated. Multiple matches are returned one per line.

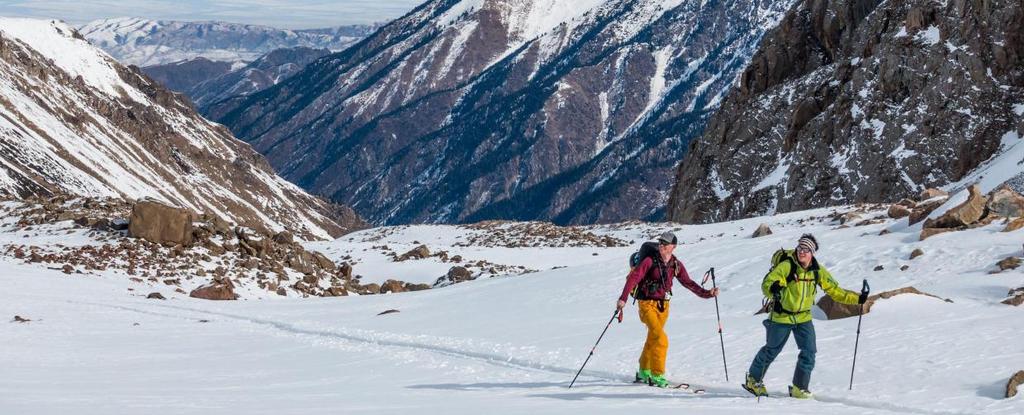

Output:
xmin=761 ymin=251 xmax=860 ymax=324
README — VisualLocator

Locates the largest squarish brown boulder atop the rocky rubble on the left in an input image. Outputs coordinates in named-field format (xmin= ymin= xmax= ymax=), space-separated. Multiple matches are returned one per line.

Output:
xmin=128 ymin=200 xmax=195 ymax=246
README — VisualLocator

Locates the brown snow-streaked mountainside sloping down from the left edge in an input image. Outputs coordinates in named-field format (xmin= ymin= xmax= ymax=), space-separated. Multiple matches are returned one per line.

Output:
xmin=0 ymin=18 xmax=361 ymax=238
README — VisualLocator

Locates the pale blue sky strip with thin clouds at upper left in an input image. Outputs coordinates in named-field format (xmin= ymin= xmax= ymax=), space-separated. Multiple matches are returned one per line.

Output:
xmin=0 ymin=0 xmax=426 ymax=29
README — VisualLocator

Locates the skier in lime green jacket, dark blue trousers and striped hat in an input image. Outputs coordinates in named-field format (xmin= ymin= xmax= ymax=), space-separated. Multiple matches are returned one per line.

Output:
xmin=743 ymin=234 xmax=867 ymax=399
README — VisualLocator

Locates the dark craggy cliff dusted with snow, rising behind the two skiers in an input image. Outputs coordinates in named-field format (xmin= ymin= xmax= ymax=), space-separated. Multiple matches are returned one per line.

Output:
xmin=669 ymin=0 xmax=1024 ymax=222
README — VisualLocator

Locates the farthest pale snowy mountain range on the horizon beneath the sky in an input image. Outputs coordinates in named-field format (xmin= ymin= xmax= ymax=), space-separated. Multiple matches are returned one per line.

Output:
xmin=79 ymin=17 xmax=376 ymax=67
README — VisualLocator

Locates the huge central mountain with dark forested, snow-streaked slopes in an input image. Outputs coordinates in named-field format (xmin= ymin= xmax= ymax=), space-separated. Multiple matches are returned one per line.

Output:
xmin=216 ymin=0 xmax=794 ymax=223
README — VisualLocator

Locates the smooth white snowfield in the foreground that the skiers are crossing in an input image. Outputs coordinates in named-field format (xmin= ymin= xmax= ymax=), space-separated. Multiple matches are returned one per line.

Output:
xmin=0 ymin=204 xmax=1024 ymax=414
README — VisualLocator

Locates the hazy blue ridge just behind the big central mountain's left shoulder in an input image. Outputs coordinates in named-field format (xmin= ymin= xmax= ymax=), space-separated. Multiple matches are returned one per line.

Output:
xmin=191 ymin=47 xmax=331 ymax=116
